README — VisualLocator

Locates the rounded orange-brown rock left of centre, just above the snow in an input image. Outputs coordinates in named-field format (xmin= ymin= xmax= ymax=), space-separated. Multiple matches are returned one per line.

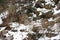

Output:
xmin=17 ymin=14 xmax=31 ymax=25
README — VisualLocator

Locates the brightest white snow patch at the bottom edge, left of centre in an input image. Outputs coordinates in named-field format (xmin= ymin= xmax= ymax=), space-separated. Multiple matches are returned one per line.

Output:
xmin=8 ymin=28 xmax=28 ymax=40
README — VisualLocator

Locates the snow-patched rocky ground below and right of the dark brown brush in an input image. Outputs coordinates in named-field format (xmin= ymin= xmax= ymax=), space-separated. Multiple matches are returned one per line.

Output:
xmin=0 ymin=0 xmax=60 ymax=40
